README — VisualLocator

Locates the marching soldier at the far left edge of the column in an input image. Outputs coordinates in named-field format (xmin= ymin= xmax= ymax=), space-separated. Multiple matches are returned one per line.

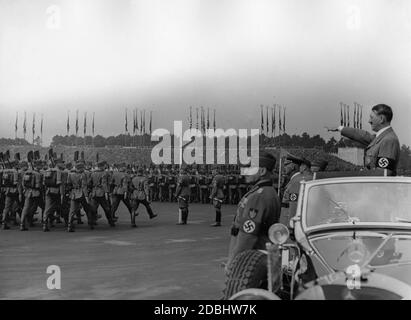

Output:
xmin=1 ymin=157 xmax=24 ymax=230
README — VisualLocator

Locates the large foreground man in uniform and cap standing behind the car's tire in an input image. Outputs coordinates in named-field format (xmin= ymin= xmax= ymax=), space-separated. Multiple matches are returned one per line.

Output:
xmin=226 ymin=152 xmax=281 ymax=271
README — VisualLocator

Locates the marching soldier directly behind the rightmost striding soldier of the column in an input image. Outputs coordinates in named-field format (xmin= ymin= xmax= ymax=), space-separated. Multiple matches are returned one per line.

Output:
xmin=111 ymin=163 xmax=132 ymax=221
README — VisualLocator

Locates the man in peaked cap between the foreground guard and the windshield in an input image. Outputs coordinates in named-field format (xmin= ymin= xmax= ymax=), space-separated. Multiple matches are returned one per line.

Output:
xmin=280 ymin=156 xmax=312 ymax=226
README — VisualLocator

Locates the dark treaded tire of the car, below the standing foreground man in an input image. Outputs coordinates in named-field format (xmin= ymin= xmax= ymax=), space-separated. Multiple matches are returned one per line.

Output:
xmin=222 ymin=250 xmax=281 ymax=300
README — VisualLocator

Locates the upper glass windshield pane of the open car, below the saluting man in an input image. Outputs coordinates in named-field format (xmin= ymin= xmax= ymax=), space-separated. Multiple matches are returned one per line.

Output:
xmin=306 ymin=182 xmax=411 ymax=227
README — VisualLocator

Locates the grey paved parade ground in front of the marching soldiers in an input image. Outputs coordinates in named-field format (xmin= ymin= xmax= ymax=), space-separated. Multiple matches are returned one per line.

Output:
xmin=0 ymin=202 xmax=236 ymax=300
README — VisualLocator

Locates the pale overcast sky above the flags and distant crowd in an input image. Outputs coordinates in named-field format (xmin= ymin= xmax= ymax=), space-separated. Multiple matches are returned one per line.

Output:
xmin=0 ymin=0 xmax=411 ymax=145
